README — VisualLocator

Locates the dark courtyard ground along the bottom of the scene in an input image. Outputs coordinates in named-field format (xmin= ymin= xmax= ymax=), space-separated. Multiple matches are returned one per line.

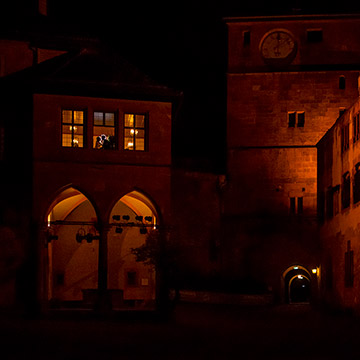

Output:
xmin=0 ymin=304 xmax=360 ymax=360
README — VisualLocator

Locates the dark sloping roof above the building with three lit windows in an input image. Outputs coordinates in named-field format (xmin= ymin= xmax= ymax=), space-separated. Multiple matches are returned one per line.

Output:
xmin=0 ymin=49 xmax=181 ymax=101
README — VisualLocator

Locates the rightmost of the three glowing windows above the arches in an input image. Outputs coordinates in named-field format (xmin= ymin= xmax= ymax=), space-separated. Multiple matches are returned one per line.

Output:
xmin=124 ymin=114 xmax=146 ymax=151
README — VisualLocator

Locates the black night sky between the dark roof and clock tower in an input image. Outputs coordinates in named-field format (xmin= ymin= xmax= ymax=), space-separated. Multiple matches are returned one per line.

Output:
xmin=38 ymin=0 xmax=360 ymax=171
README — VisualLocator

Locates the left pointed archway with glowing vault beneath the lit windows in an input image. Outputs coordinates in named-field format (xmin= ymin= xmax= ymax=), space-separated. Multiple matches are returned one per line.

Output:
xmin=46 ymin=188 xmax=99 ymax=307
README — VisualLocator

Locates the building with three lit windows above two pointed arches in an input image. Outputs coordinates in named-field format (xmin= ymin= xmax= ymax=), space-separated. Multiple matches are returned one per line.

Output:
xmin=0 ymin=33 xmax=180 ymax=311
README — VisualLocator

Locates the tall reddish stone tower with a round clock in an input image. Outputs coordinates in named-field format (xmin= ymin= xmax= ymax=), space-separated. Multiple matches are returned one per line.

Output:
xmin=222 ymin=15 xmax=360 ymax=302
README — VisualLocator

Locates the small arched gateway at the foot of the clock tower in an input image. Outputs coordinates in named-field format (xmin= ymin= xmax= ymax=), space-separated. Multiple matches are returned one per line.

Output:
xmin=283 ymin=265 xmax=311 ymax=304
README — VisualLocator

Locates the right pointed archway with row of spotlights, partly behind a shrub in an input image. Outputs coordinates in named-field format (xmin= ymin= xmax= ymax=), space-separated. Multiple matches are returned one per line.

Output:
xmin=107 ymin=191 xmax=159 ymax=309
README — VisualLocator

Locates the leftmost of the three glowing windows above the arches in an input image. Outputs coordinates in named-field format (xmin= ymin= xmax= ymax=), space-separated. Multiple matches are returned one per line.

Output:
xmin=61 ymin=110 xmax=84 ymax=147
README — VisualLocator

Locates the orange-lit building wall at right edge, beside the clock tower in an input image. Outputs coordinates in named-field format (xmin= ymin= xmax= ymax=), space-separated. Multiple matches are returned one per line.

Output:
xmin=318 ymin=94 xmax=360 ymax=314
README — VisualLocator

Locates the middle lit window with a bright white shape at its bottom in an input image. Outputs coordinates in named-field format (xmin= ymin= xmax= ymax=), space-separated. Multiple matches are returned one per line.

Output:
xmin=93 ymin=111 xmax=116 ymax=149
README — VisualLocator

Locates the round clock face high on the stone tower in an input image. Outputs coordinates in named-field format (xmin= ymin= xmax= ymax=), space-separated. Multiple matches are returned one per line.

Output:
xmin=260 ymin=29 xmax=297 ymax=66
